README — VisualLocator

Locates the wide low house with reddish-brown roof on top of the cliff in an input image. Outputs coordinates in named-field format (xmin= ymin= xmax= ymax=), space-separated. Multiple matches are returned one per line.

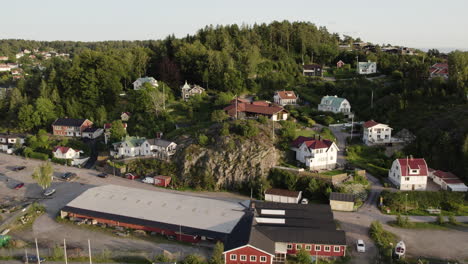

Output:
xmin=224 ymin=99 xmax=289 ymax=121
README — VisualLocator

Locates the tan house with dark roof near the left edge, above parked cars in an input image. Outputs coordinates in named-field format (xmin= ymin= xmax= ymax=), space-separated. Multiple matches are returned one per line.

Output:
xmin=52 ymin=118 xmax=93 ymax=137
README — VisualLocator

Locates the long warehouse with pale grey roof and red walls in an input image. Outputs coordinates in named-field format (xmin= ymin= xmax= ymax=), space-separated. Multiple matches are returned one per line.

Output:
xmin=61 ymin=185 xmax=248 ymax=243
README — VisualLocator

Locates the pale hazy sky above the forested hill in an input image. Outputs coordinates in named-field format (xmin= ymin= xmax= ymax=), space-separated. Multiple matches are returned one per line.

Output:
xmin=0 ymin=0 xmax=468 ymax=50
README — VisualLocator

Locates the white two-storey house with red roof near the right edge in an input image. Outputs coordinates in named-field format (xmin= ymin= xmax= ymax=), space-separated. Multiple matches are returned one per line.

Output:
xmin=388 ymin=157 xmax=429 ymax=191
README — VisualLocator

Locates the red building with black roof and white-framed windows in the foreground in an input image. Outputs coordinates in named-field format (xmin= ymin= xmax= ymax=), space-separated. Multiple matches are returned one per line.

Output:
xmin=223 ymin=202 xmax=346 ymax=264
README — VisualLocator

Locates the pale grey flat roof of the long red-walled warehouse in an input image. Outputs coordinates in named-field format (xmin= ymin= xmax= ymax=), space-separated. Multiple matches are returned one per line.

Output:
xmin=66 ymin=185 xmax=245 ymax=234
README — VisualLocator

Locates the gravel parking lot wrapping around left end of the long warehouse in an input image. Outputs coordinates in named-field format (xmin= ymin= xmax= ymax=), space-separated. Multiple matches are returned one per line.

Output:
xmin=0 ymin=154 xmax=247 ymax=256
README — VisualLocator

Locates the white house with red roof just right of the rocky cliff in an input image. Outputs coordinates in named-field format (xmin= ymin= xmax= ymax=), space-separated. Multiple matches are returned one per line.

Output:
xmin=291 ymin=136 xmax=339 ymax=170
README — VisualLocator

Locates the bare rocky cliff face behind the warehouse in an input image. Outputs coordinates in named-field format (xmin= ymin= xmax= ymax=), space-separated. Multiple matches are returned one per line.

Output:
xmin=175 ymin=123 xmax=279 ymax=189
